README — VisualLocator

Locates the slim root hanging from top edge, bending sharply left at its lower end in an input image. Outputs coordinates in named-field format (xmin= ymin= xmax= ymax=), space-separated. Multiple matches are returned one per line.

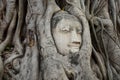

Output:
xmin=4 ymin=0 xmax=24 ymax=77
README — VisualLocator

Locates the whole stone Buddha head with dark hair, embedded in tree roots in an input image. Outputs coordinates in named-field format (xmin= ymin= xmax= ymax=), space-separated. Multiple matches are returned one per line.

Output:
xmin=51 ymin=11 xmax=82 ymax=55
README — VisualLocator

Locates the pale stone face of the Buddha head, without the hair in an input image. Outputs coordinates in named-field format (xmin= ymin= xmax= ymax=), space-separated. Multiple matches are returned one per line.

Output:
xmin=52 ymin=19 xmax=82 ymax=55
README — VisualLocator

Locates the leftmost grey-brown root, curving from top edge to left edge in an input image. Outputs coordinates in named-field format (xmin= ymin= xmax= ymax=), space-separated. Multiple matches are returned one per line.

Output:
xmin=0 ymin=0 xmax=16 ymax=41
